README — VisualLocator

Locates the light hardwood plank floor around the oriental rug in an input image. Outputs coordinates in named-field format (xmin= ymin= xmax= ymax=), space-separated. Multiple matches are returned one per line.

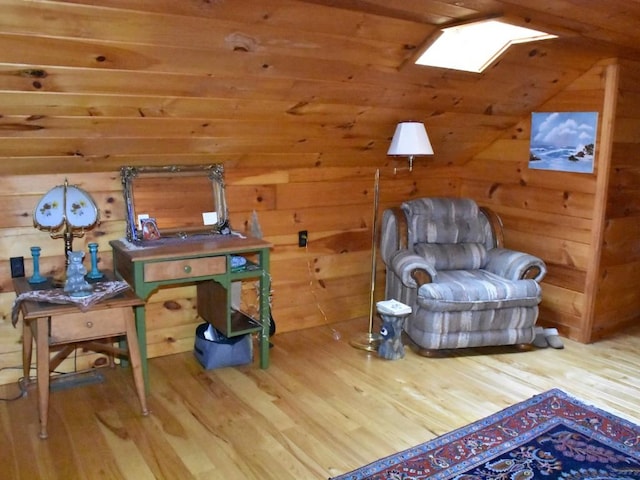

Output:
xmin=0 ymin=320 xmax=640 ymax=480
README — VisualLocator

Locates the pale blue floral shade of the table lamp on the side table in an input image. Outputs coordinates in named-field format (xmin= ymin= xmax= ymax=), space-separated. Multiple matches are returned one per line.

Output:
xmin=33 ymin=180 xmax=99 ymax=236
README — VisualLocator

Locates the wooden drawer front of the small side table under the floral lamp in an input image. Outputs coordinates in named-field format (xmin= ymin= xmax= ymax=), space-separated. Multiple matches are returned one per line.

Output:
xmin=50 ymin=307 xmax=128 ymax=345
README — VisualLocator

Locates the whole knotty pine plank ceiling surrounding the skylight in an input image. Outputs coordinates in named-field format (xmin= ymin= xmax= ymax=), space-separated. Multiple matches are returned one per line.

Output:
xmin=0 ymin=0 xmax=640 ymax=173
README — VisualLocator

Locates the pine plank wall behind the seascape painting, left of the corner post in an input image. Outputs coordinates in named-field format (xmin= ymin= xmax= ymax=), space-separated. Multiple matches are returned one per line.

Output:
xmin=462 ymin=61 xmax=608 ymax=340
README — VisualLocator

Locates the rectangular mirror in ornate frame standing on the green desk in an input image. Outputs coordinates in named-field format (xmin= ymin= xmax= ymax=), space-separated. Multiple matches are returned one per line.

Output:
xmin=120 ymin=164 xmax=229 ymax=241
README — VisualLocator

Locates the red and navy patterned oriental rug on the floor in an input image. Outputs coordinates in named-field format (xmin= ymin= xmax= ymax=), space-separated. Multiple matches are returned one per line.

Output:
xmin=333 ymin=389 xmax=640 ymax=480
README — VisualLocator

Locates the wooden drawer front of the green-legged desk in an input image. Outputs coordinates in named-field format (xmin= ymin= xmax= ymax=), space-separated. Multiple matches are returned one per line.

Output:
xmin=144 ymin=255 xmax=227 ymax=282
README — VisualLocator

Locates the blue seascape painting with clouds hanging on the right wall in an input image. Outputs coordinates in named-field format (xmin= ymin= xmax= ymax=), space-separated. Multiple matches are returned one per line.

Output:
xmin=529 ymin=112 xmax=598 ymax=173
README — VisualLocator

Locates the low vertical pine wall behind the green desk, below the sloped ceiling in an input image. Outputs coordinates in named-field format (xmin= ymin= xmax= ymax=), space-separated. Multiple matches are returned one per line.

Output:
xmin=0 ymin=167 xmax=457 ymax=381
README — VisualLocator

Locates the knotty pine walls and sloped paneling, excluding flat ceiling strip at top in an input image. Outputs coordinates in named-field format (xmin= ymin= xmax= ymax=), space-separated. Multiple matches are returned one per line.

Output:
xmin=0 ymin=0 xmax=640 ymax=383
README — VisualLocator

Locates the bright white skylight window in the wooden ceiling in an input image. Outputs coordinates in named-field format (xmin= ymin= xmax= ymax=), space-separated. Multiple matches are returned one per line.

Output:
xmin=416 ymin=20 xmax=557 ymax=73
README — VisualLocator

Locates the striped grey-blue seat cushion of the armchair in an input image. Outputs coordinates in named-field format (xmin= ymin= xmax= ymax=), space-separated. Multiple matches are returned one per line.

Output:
xmin=418 ymin=270 xmax=542 ymax=312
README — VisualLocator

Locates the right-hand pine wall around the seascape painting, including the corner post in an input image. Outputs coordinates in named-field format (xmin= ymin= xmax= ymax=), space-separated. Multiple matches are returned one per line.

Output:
xmin=461 ymin=61 xmax=640 ymax=342
